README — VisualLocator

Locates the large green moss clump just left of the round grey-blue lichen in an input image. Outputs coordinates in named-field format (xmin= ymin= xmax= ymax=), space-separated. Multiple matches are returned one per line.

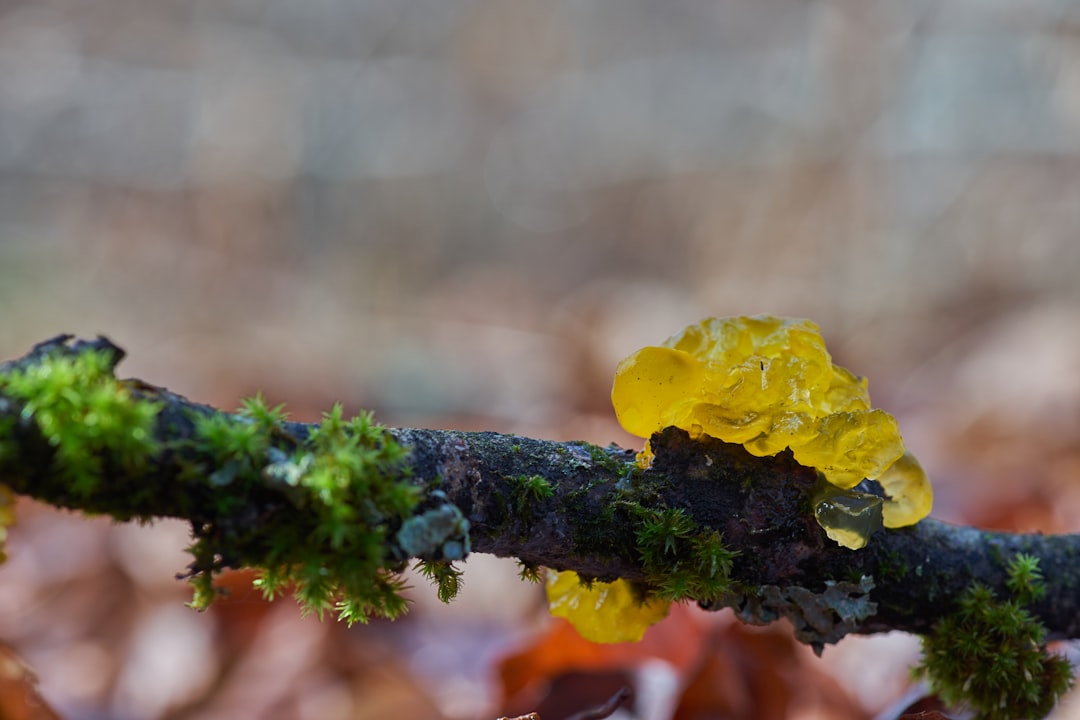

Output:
xmin=185 ymin=397 xmax=421 ymax=623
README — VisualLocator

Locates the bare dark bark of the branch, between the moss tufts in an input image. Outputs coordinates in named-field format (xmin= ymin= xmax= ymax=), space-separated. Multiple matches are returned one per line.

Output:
xmin=0 ymin=337 xmax=1080 ymax=648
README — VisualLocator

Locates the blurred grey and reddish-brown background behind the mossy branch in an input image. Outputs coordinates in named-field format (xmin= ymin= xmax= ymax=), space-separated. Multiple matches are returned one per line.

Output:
xmin=0 ymin=0 xmax=1080 ymax=720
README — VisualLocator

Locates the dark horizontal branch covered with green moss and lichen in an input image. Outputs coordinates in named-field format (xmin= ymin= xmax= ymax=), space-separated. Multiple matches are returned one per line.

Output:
xmin=0 ymin=337 xmax=1080 ymax=648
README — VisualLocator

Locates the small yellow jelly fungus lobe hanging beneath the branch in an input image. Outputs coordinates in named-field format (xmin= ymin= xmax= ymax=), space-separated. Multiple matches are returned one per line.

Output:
xmin=546 ymin=570 xmax=671 ymax=642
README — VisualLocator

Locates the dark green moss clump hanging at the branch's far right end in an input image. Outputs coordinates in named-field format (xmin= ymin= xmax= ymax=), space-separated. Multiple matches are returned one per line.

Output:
xmin=916 ymin=555 xmax=1072 ymax=720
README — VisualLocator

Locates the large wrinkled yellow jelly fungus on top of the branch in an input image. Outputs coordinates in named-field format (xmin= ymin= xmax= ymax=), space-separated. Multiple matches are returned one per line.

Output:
xmin=611 ymin=315 xmax=932 ymax=547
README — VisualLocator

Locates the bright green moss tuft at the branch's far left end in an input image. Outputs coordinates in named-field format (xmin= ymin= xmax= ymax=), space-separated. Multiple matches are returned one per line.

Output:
xmin=0 ymin=350 xmax=161 ymax=497
